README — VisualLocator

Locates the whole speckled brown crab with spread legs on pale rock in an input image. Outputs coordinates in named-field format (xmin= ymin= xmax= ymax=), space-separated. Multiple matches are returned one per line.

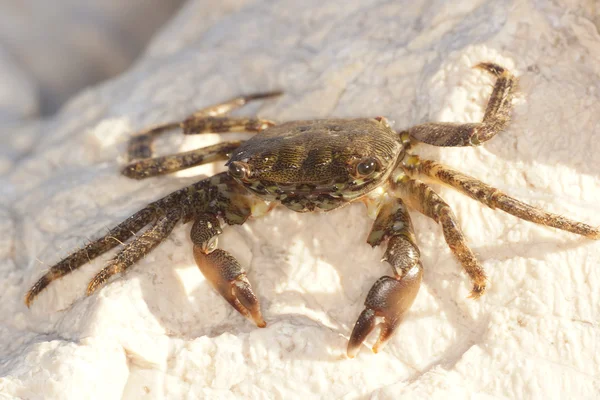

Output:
xmin=25 ymin=62 xmax=600 ymax=358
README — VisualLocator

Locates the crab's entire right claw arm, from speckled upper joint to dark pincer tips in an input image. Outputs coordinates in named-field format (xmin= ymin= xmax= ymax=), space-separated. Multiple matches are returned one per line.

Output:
xmin=347 ymin=199 xmax=423 ymax=358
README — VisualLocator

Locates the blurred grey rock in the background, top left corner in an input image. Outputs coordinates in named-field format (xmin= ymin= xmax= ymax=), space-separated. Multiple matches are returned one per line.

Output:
xmin=0 ymin=0 xmax=183 ymax=122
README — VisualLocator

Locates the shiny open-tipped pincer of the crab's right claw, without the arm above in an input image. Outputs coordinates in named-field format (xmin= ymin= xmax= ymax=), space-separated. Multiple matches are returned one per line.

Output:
xmin=347 ymin=262 xmax=423 ymax=358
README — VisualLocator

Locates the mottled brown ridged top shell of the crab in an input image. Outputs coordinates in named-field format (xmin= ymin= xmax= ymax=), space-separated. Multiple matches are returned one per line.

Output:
xmin=230 ymin=118 xmax=402 ymax=185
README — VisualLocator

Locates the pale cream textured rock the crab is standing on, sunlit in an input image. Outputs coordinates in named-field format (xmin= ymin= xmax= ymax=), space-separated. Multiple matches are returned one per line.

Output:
xmin=0 ymin=0 xmax=600 ymax=399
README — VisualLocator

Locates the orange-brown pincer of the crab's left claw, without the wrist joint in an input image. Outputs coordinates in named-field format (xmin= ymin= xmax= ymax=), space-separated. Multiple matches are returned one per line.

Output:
xmin=194 ymin=245 xmax=267 ymax=328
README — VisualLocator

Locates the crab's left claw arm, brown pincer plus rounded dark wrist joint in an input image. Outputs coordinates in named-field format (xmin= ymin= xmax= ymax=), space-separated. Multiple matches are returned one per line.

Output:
xmin=190 ymin=213 xmax=267 ymax=328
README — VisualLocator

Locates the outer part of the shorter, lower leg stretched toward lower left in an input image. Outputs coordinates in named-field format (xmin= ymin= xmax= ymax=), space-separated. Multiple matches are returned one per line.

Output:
xmin=86 ymin=208 xmax=181 ymax=296
